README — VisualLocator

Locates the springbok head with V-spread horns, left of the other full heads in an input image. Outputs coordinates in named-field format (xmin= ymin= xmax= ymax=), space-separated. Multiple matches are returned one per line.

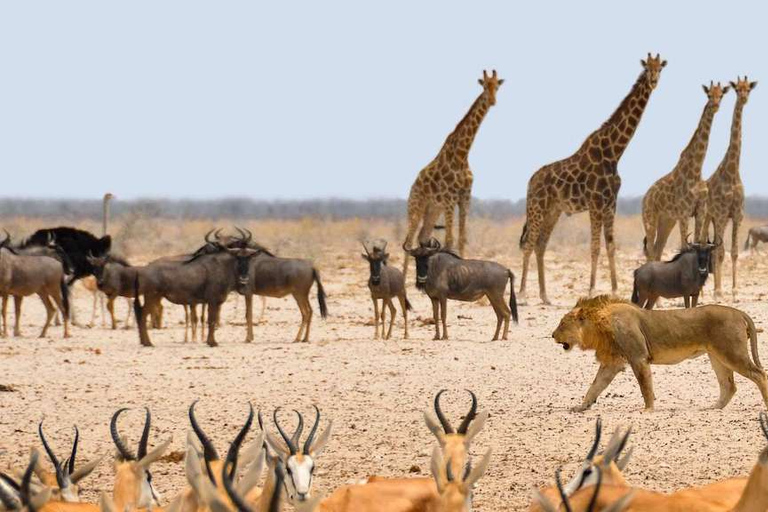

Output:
xmin=35 ymin=421 xmax=101 ymax=503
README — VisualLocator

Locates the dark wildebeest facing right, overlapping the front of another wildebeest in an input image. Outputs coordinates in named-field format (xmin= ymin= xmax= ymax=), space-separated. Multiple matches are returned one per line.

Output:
xmin=133 ymin=244 xmax=257 ymax=347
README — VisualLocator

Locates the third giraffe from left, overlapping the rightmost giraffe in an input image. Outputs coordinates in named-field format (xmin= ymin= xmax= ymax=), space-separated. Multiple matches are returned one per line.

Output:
xmin=643 ymin=81 xmax=729 ymax=261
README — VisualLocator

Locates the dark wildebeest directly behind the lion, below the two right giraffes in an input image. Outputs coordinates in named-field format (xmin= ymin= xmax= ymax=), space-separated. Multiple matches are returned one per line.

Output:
xmin=632 ymin=242 xmax=716 ymax=309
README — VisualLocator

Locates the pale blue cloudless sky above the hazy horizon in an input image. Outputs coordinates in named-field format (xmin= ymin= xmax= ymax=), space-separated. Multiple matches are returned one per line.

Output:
xmin=0 ymin=0 xmax=768 ymax=199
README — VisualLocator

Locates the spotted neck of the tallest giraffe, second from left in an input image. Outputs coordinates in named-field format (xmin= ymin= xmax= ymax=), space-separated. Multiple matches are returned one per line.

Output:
xmin=585 ymin=71 xmax=652 ymax=162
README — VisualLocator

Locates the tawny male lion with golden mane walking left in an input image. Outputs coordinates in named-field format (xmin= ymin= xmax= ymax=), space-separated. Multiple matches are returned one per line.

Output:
xmin=552 ymin=295 xmax=768 ymax=412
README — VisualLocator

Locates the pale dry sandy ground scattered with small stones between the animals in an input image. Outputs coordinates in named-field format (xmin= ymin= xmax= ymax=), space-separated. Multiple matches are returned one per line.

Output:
xmin=0 ymin=214 xmax=768 ymax=511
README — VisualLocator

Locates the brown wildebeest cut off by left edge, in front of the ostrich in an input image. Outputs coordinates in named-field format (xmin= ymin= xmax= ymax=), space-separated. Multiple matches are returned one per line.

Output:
xmin=0 ymin=231 xmax=69 ymax=338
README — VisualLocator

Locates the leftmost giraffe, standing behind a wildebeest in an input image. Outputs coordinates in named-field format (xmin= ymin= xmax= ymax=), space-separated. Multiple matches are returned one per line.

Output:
xmin=403 ymin=69 xmax=504 ymax=276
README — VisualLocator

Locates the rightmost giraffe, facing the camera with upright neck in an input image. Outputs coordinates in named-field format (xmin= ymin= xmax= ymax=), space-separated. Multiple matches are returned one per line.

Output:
xmin=704 ymin=76 xmax=757 ymax=298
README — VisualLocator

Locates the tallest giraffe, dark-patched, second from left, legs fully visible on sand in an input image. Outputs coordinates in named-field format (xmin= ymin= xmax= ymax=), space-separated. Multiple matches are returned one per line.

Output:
xmin=520 ymin=53 xmax=667 ymax=304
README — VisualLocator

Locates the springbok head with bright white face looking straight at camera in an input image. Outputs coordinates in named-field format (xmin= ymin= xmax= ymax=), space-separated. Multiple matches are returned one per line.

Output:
xmin=259 ymin=405 xmax=333 ymax=502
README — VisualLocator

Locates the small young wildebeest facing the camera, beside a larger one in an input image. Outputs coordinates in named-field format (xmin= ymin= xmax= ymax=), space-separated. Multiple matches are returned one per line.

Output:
xmin=363 ymin=240 xmax=412 ymax=340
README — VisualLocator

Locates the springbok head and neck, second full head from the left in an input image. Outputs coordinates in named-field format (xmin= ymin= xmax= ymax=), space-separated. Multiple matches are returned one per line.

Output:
xmin=109 ymin=408 xmax=172 ymax=511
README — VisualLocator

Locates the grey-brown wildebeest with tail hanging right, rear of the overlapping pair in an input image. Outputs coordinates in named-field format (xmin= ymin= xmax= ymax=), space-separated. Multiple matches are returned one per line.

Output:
xmin=237 ymin=232 xmax=328 ymax=343
